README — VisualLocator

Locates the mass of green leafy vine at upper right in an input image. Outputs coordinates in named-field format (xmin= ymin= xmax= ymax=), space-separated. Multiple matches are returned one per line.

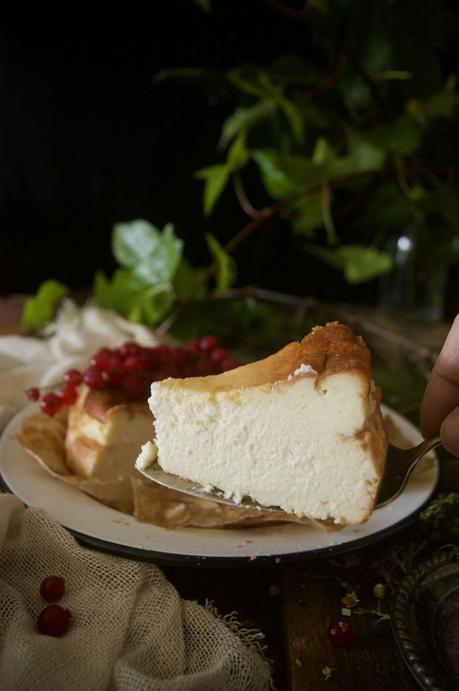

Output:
xmin=169 ymin=0 xmax=459 ymax=290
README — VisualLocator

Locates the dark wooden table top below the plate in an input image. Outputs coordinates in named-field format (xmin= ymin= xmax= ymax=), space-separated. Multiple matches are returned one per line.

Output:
xmin=0 ymin=299 xmax=459 ymax=691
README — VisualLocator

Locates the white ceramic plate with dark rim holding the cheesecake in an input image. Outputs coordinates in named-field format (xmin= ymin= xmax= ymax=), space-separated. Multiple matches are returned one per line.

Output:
xmin=0 ymin=406 xmax=439 ymax=566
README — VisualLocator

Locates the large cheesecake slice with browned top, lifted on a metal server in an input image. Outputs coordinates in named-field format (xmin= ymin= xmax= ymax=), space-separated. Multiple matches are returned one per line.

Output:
xmin=149 ymin=323 xmax=387 ymax=525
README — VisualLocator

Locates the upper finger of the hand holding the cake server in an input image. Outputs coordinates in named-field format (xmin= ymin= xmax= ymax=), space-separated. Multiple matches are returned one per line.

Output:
xmin=421 ymin=315 xmax=459 ymax=437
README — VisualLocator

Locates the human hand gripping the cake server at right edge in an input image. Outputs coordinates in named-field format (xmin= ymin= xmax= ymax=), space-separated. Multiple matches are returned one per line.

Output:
xmin=421 ymin=315 xmax=459 ymax=456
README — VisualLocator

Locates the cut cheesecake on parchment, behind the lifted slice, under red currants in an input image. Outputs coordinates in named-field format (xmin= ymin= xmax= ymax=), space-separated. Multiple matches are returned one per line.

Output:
xmin=65 ymin=385 xmax=151 ymax=481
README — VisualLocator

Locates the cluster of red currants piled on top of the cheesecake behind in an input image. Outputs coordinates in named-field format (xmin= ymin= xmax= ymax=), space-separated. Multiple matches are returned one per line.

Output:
xmin=26 ymin=336 xmax=240 ymax=415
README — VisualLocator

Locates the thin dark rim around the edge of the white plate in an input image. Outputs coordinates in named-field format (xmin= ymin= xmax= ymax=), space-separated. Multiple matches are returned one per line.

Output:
xmin=0 ymin=405 xmax=442 ymax=568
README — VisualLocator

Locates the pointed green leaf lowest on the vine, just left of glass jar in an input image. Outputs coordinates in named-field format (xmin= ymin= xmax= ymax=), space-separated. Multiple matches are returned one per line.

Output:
xmin=307 ymin=244 xmax=392 ymax=284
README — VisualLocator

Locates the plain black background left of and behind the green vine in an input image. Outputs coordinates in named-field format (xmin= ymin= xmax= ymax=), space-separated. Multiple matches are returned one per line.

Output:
xmin=0 ymin=0 xmax=458 ymax=312
